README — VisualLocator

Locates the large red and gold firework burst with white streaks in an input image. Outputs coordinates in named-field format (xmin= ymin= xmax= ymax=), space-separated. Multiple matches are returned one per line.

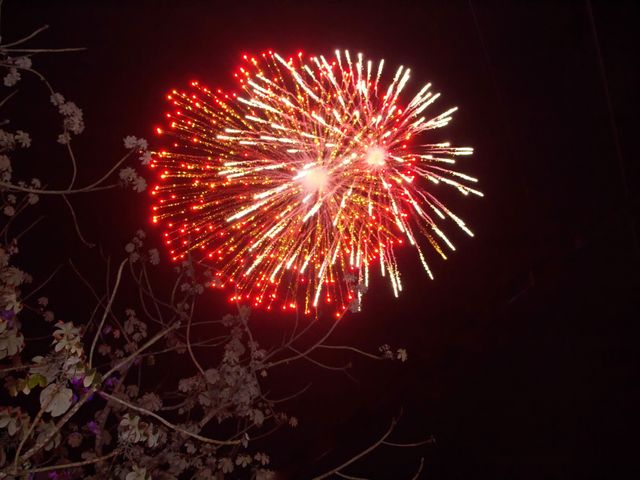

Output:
xmin=151 ymin=51 xmax=482 ymax=316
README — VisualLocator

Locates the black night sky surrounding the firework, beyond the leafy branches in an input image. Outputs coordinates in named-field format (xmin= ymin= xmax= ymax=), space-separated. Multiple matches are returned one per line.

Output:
xmin=2 ymin=0 xmax=640 ymax=479
